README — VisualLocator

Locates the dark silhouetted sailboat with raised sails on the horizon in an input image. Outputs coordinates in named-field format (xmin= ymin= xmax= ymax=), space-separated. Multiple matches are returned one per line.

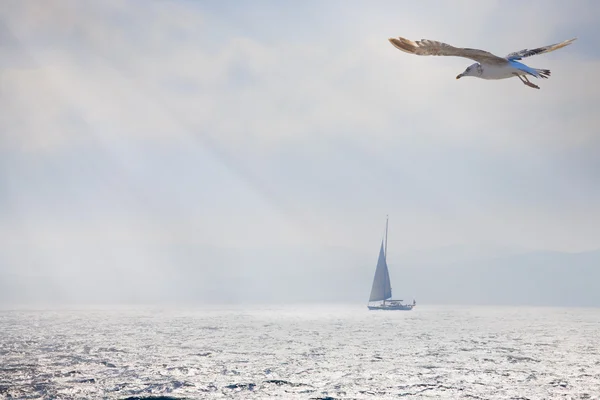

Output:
xmin=367 ymin=217 xmax=417 ymax=311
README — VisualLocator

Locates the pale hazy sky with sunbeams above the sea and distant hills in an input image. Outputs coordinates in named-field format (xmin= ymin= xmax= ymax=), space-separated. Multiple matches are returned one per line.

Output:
xmin=0 ymin=0 xmax=600 ymax=302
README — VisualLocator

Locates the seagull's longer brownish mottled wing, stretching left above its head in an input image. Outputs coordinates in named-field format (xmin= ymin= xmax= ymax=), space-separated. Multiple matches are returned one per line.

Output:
xmin=388 ymin=37 xmax=508 ymax=65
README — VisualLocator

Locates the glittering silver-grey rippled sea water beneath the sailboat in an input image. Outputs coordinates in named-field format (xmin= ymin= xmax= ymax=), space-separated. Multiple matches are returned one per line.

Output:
xmin=0 ymin=305 xmax=600 ymax=399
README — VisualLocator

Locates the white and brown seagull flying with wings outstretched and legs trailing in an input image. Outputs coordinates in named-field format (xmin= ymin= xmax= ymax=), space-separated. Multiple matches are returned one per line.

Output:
xmin=388 ymin=37 xmax=577 ymax=89
